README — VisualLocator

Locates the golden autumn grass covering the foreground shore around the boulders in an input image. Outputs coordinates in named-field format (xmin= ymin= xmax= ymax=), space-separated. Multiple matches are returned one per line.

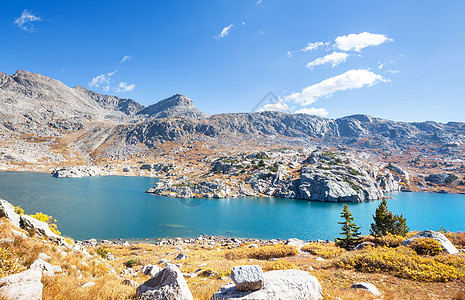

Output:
xmin=0 ymin=216 xmax=465 ymax=300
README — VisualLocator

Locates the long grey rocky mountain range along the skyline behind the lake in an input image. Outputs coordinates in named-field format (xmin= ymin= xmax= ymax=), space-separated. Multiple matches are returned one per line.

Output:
xmin=0 ymin=70 xmax=465 ymax=150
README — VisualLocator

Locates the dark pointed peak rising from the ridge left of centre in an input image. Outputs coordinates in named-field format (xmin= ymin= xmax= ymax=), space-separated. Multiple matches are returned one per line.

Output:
xmin=138 ymin=94 xmax=208 ymax=119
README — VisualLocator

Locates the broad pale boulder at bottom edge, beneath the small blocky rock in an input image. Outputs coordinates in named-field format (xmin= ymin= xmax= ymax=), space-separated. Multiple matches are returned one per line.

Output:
xmin=212 ymin=270 xmax=323 ymax=300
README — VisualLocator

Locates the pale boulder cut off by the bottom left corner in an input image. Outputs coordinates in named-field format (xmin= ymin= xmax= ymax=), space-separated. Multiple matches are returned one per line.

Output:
xmin=0 ymin=269 xmax=43 ymax=300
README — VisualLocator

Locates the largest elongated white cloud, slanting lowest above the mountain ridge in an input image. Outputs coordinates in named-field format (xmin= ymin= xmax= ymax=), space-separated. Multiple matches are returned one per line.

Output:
xmin=286 ymin=69 xmax=386 ymax=105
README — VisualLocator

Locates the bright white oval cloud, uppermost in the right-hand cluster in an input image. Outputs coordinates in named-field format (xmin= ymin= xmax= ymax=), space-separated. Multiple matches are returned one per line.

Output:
xmin=334 ymin=32 xmax=393 ymax=52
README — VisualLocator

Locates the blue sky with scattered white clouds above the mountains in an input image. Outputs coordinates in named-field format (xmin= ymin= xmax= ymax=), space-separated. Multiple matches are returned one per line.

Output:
xmin=0 ymin=0 xmax=465 ymax=122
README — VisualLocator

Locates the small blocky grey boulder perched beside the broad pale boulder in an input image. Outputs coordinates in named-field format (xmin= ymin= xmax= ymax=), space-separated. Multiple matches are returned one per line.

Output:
xmin=231 ymin=265 xmax=263 ymax=291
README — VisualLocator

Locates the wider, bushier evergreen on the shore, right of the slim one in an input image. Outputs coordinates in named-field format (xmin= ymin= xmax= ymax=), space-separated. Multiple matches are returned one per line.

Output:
xmin=370 ymin=198 xmax=409 ymax=236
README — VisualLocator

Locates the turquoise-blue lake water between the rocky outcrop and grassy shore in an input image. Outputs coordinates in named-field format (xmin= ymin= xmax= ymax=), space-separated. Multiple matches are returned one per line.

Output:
xmin=0 ymin=172 xmax=465 ymax=240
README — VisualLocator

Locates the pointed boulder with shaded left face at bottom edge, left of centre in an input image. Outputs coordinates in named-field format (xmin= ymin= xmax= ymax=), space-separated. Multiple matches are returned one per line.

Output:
xmin=136 ymin=264 xmax=193 ymax=300
